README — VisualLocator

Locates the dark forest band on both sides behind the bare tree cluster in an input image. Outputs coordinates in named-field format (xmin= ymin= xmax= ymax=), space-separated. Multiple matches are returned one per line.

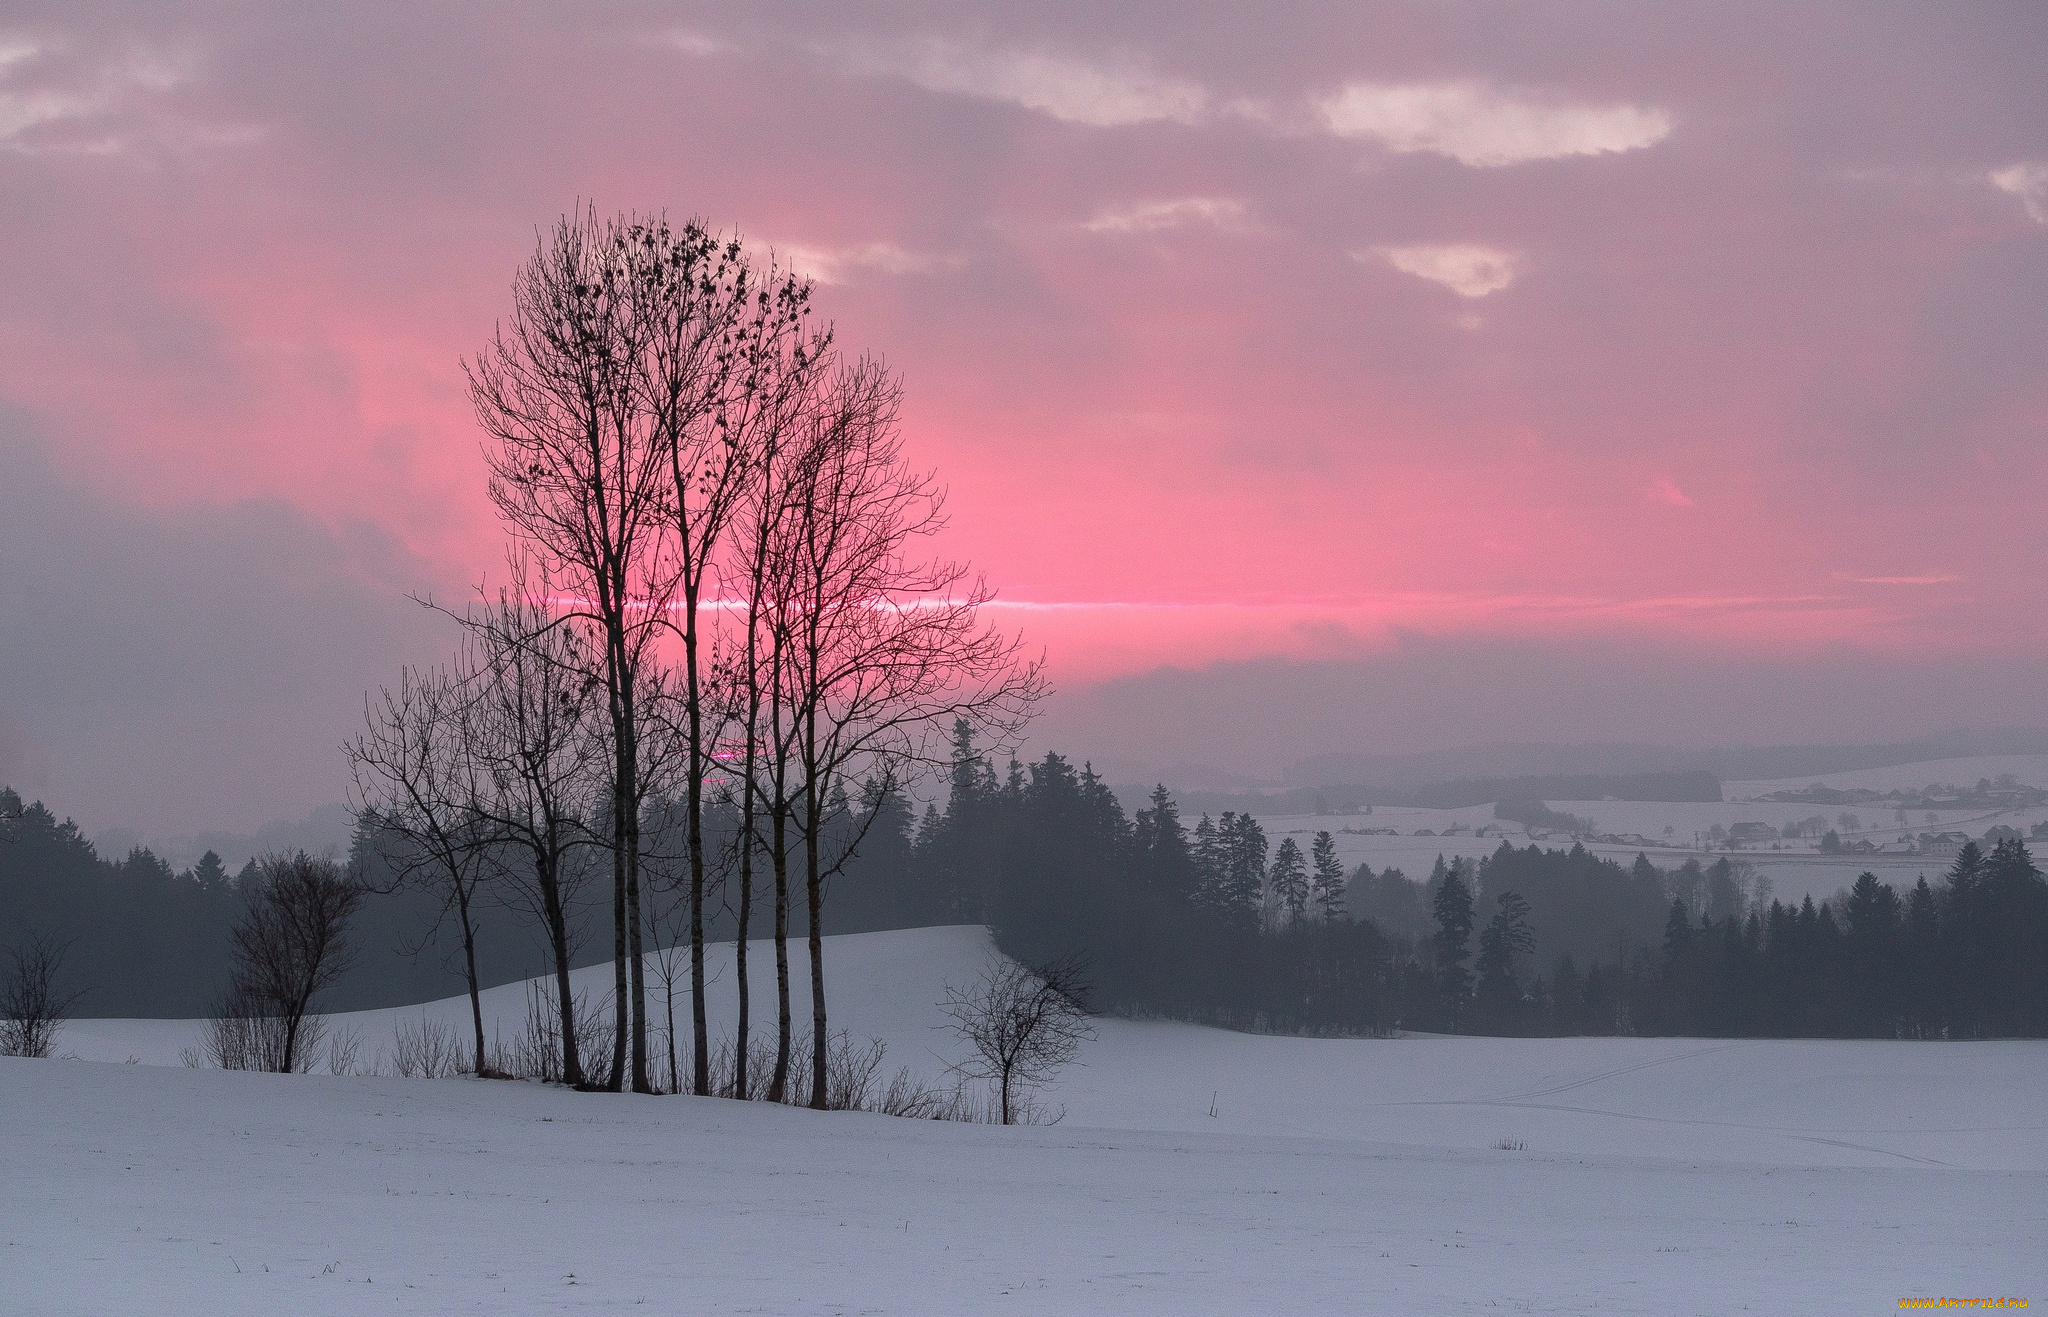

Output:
xmin=0 ymin=727 xmax=2048 ymax=1038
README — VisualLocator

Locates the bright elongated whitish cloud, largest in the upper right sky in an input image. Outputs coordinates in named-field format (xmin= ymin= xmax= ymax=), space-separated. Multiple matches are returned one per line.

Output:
xmin=1317 ymin=82 xmax=1671 ymax=166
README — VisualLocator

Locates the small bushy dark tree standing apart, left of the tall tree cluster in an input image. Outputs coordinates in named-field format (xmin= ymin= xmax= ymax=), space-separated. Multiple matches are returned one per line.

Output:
xmin=221 ymin=850 xmax=362 ymax=1073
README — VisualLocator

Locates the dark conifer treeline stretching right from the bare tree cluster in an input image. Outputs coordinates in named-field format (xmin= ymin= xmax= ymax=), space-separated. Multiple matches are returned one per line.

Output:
xmin=848 ymin=729 xmax=2048 ymax=1038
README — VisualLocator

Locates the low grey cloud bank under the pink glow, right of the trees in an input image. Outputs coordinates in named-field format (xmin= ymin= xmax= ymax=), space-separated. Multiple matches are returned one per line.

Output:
xmin=1032 ymin=635 xmax=2048 ymax=778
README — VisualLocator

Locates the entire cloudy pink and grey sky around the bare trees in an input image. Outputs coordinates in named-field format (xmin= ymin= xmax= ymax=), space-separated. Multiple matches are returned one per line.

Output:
xmin=0 ymin=0 xmax=2048 ymax=832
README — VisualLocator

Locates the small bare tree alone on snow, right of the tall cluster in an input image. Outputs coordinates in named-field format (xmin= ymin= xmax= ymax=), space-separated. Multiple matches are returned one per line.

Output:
xmin=944 ymin=957 xmax=1096 ymax=1124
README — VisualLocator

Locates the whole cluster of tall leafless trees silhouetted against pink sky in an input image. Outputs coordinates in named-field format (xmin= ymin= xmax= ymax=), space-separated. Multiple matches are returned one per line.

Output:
xmin=348 ymin=211 xmax=1042 ymax=1106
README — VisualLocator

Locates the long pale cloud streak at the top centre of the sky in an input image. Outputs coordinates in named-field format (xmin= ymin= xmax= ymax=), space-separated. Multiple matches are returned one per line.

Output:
xmin=838 ymin=37 xmax=1208 ymax=127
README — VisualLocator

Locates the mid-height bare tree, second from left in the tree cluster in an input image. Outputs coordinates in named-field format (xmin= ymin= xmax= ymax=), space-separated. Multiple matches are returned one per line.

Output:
xmin=467 ymin=577 xmax=606 ymax=1088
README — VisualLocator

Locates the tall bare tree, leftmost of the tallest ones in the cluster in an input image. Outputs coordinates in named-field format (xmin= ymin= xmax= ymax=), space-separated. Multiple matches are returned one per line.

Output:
xmin=465 ymin=209 xmax=676 ymax=1092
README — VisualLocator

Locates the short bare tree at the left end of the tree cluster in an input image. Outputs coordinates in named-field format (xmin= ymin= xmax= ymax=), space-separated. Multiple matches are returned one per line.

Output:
xmin=342 ymin=668 xmax=492 ymax=1075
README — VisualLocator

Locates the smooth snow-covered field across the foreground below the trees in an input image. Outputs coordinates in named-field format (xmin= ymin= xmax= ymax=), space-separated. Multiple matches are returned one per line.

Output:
xmin=0 ymin=928 xmax=2048 ymax=1317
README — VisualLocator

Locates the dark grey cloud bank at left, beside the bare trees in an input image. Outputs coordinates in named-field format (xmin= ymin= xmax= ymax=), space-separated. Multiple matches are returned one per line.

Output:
xmin=0 ymin=412 xmax=453 ymax=834
